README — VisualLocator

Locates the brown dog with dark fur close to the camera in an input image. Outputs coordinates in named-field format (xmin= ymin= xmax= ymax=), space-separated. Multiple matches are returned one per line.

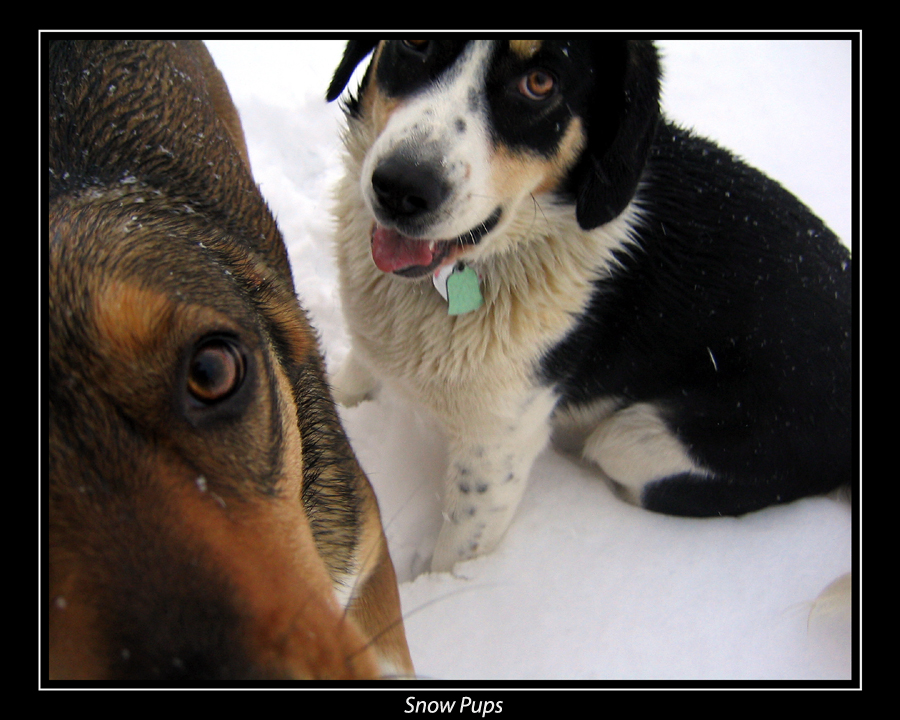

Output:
xmin=47 ymin=41 xmax=413 ymax=680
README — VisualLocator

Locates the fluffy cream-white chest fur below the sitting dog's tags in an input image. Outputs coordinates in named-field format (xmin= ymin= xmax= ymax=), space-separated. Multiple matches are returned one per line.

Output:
xmin=336 ymin=138 xmax=633 ymax=425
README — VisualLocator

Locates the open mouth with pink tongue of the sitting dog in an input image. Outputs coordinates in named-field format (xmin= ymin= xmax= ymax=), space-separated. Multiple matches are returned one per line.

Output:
xmin=372 ymin=208 xmax=502 ymax=278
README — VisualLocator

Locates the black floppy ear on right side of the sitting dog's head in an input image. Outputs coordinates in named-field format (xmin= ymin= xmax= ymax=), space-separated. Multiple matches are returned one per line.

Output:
xmin=572 ymin=40 xmax=660 ymax=230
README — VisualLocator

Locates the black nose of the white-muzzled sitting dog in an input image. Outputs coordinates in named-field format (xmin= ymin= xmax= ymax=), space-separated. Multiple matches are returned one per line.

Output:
xmin=372 ymin=155 xmax=449 ymax=220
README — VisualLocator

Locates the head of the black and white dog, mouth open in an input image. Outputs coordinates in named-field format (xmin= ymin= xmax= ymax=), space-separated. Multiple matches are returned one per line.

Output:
xmin=328 ymin=39 xmax=659 ymax=277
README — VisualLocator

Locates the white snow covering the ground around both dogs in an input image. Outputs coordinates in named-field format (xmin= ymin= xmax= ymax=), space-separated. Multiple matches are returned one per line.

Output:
xmin=208 ymin=40 xmax=853 ymax=686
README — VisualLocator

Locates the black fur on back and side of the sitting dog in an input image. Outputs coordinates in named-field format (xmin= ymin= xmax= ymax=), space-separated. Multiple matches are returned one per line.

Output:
xmin=542 ymin=121 xmax=855 ymax=514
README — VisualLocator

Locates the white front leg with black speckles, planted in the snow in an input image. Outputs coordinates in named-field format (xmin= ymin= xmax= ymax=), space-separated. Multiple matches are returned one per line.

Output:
xmin=431 ymin=390 xmax=555 ymax=572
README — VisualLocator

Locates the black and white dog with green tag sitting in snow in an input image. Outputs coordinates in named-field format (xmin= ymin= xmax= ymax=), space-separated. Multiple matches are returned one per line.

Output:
xmin=328 ymin=37 xmax=857 ymax=570
